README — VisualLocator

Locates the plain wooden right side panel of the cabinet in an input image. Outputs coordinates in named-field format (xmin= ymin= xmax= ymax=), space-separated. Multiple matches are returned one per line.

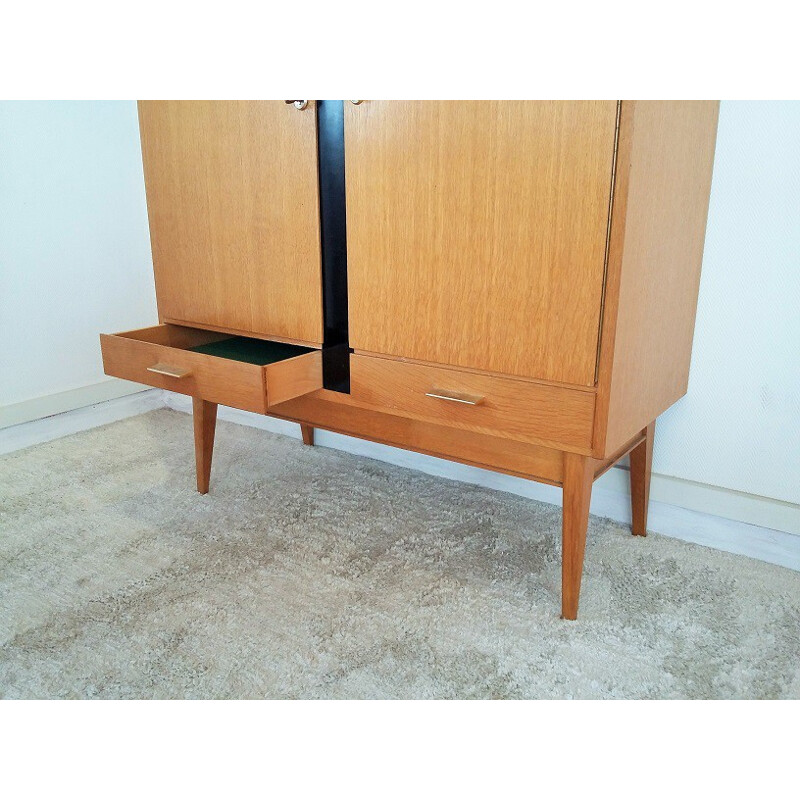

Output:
xmin=594 ymin=101 xmax=719 ymax=458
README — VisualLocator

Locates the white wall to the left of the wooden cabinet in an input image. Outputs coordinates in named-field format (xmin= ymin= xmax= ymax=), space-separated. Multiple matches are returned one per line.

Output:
xmin=0 ymin=102 xmax=157 ymax=424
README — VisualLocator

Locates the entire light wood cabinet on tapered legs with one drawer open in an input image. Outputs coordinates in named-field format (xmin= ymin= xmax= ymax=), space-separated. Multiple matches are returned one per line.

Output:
xmin=101 ymin=100 xmax=718 ymax=619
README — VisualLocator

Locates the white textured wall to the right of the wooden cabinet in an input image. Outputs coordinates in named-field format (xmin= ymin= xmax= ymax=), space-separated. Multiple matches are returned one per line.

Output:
xmin=653 ymin=101 xmax=800 ymax=503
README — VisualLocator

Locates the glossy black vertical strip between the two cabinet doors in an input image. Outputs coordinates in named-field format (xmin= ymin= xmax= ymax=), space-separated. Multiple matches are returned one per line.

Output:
xmin=316 ymin=100 xmax=350 ymax=392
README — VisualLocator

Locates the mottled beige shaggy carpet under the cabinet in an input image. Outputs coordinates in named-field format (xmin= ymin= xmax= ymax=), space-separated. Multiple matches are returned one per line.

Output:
xmin=0 ymin=410 xmax=800 ymax=698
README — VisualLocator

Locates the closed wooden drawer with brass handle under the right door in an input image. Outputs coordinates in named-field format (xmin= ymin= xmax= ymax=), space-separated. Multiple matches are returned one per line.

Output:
xmin=350 ymin=355 xmax=595 ymax=452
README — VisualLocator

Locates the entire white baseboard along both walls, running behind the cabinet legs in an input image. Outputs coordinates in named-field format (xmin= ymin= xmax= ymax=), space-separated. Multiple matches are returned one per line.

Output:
xmin=0 ymin=389 xmax=800 ymax=571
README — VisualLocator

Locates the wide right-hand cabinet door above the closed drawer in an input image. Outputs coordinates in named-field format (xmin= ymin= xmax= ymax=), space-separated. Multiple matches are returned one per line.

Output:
xmin=345 ymin=100 xmax=617 ymax=385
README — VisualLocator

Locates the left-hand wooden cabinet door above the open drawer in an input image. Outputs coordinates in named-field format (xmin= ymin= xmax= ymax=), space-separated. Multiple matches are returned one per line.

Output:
xmin=139 ymin=100 xmax=322 ymax=344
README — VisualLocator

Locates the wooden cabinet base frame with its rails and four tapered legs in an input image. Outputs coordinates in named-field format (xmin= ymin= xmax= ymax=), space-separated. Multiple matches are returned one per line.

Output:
xmin=192 ymin=390 xmax=655 ymax=620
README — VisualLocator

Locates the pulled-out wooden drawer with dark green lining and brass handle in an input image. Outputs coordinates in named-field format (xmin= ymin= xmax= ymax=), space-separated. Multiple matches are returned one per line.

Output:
xmin=100 ymin=325 xmax=322 ymax=414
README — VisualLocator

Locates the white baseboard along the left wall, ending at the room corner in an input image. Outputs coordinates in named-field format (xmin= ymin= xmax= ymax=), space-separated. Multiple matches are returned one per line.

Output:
xmin=0 ymin=384 xmax=164 ymax=455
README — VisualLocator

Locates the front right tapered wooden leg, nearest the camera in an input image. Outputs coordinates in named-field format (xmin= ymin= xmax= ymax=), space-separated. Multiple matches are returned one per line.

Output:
xmin=561 ymin=453 xmax=595 ymax=619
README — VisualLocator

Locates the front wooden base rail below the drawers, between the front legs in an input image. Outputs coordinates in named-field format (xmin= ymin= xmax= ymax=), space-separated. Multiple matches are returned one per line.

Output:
xmin=269 ymin=389 xmax=563 ymax=485
